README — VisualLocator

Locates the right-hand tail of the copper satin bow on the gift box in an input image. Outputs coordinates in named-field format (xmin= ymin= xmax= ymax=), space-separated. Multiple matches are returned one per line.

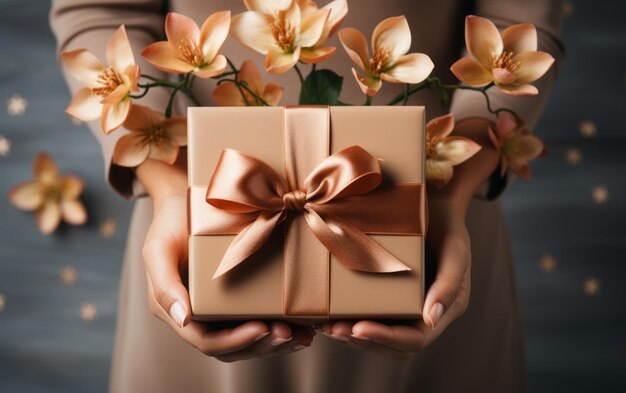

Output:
xmin=304 ymin=204 xmax=411 ymax=273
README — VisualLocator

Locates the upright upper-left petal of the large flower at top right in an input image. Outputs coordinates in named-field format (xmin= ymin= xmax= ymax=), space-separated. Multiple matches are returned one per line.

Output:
xmin=465 ymin=15 xmax=504 ymax=69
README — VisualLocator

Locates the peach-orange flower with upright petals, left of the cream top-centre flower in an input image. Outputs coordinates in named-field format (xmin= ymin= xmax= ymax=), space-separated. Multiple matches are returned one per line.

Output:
xmin=141 ymin=11 xmax=230 ymax=78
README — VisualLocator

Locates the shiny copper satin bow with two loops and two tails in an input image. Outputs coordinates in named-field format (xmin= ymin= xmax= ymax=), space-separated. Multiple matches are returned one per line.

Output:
xmin=206 ymin=146 xmax=411 ymax=278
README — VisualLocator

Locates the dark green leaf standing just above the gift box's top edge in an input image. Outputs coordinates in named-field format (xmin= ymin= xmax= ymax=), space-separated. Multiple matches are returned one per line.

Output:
xmin=300 ymin=70 xmax=343 ymax=105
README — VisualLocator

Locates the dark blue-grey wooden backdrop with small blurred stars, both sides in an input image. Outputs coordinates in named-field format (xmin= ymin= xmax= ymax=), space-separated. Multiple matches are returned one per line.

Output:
xmin=0 ymin=0 xmax=626 ymax=392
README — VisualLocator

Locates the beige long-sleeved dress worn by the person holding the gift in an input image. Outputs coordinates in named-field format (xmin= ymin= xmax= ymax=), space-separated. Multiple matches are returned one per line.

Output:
xmin=51 ymin=0 xmax=563 ymax=393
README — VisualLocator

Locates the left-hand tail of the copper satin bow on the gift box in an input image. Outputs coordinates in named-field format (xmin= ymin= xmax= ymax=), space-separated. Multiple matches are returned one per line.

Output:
xmin=212 ymin=212 xmax=283 ymax=279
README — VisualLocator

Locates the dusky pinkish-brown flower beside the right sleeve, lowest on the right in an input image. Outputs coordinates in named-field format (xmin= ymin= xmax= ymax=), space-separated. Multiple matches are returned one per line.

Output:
xmin=489 ymin=112 xmax=545 ymax=180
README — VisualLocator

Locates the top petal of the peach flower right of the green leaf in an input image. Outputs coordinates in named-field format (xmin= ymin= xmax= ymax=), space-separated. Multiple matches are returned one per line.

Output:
xmin=372 ymin=16 xmax=411 ymax=64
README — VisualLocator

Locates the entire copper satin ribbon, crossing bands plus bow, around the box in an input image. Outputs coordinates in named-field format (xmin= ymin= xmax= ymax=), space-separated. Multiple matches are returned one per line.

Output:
xmin=189 ymin=107 xmax=426 ymax=317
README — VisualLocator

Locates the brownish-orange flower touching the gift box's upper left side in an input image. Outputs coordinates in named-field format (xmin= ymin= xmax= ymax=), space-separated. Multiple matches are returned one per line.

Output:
xmin=113 ymin=105 xmax=187 ymax=167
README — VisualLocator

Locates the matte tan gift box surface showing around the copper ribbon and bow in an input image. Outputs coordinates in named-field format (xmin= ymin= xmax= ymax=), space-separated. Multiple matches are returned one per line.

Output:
xmin=188 ymin=106 xmax=426 ymax=323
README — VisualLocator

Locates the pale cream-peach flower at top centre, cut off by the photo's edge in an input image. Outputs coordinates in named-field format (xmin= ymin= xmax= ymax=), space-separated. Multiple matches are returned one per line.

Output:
xmin=232 ymin=0 xmax=332 ymax=74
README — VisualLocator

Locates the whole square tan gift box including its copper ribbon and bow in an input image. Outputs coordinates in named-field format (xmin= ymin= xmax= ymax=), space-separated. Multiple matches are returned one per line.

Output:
xmin=188 ymin=106 xmax=427 ymax=324
